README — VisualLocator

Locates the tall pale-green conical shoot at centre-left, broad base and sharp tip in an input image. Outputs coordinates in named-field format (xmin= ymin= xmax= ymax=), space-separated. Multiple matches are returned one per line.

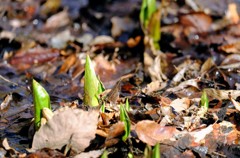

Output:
xmin=83 ymin=55 xmax=104 ymax=106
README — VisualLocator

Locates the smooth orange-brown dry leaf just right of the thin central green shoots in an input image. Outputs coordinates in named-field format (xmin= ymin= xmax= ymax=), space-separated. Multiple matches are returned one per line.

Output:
xmin=135 ymin=120 xmax=178 ymax=146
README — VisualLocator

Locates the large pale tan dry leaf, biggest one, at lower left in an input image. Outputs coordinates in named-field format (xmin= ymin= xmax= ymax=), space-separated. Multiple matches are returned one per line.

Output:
xmin=32 ymin=108 xmax=99 ymax=153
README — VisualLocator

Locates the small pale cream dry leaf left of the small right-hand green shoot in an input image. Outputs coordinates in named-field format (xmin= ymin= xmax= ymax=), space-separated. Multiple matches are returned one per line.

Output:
xmin=170 ymin=98 xmax=191 ymax=113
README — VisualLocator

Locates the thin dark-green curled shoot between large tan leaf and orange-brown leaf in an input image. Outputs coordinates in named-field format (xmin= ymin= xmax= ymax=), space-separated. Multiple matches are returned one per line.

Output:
xmin=120 ymin=105 xmax=131 ymax=141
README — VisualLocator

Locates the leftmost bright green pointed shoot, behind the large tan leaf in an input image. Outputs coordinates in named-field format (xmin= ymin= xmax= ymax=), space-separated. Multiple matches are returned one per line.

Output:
xmin=32 ymin=80 xmax=51 ymax=130
